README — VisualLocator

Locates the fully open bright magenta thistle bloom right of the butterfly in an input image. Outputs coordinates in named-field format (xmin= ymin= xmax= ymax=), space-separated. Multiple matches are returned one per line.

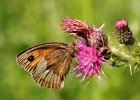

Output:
xmin=75 ymin=41 xmax=105 ymax=80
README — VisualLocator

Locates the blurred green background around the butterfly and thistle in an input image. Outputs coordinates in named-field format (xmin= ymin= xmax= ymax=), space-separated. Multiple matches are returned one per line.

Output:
xmin=0 ymin=0 xmax=140 ymax=100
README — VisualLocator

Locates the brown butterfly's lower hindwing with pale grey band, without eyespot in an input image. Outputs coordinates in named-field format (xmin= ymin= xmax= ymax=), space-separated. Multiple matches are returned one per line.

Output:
xmin=32 ymin=49 xmax=72 ymax=89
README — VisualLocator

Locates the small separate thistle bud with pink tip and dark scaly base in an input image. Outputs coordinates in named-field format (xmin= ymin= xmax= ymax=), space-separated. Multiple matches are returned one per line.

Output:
xmin=115 ymin=19 xmax=135 ymax=45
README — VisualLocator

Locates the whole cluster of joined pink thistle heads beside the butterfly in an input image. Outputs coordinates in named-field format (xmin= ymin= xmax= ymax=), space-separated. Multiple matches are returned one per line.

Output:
xmin=62 ymin=18 xmax=109 ymax=80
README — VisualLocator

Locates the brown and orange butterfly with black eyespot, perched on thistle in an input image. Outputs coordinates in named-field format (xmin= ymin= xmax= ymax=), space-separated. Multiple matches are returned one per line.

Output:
xmin=16 ymin=42 xmax=74 ymax=89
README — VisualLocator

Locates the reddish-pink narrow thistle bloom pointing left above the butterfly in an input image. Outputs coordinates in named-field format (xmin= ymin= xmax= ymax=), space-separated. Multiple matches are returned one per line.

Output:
xmin=62 ymin=18 xmax=89 ymax=33
